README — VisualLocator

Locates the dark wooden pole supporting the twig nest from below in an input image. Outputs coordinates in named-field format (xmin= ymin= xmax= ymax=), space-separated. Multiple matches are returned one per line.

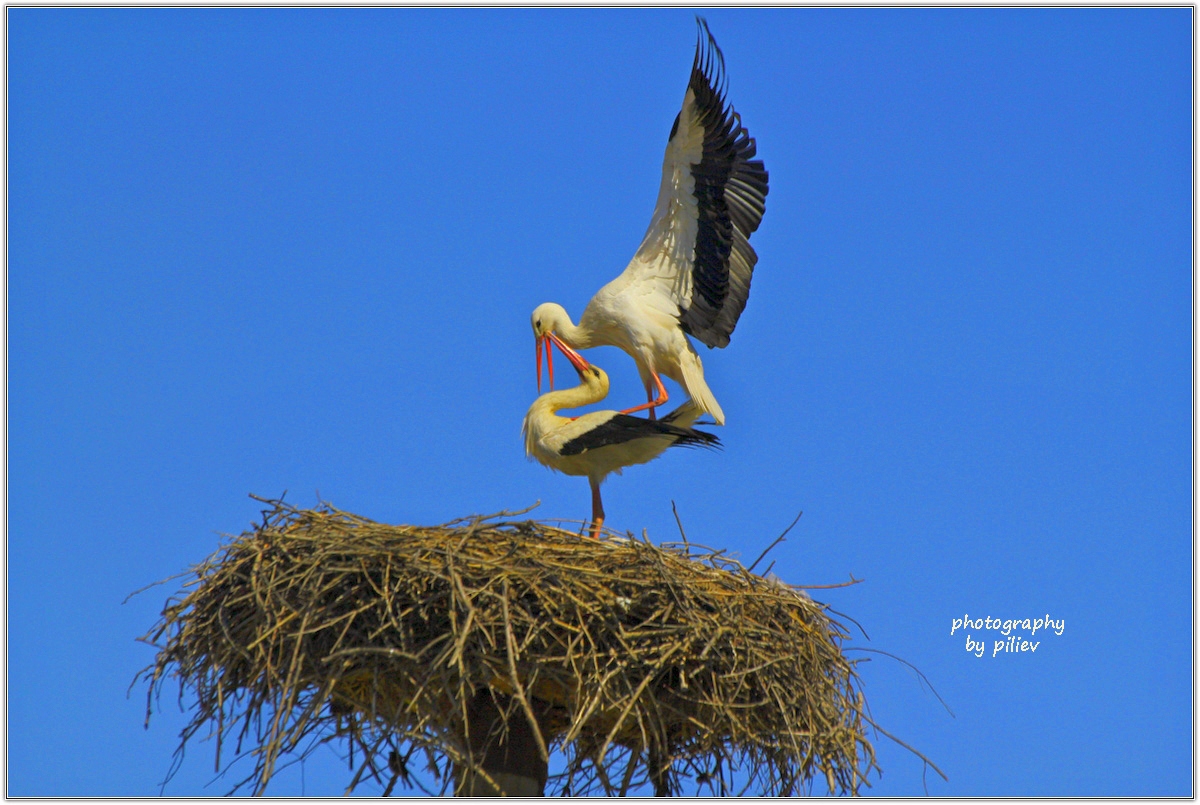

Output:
xmin=454 ymin=689 xmax=548 ymax=797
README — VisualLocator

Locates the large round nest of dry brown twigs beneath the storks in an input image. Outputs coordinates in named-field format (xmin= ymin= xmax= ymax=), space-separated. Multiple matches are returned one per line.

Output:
xmin=143 ymin=500 xmax=877 ymax=795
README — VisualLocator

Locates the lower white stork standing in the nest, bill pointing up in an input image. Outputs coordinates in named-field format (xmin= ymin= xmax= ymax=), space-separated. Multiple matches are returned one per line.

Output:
xmin=521 ymin=334 xmax=721 ymax=539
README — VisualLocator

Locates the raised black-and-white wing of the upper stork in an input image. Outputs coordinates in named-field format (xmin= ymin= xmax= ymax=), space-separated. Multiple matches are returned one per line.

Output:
xmin=625 ymin=17 xmax=767 ymax=347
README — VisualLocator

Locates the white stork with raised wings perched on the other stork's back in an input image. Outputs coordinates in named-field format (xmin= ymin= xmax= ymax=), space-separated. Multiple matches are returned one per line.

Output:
xmin=532 ymin=17 xmax=767 ymax=425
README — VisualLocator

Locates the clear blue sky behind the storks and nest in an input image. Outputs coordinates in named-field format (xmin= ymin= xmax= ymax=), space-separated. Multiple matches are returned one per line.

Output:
xmin=7 ymin=8 xmax=1193 ymax=795
